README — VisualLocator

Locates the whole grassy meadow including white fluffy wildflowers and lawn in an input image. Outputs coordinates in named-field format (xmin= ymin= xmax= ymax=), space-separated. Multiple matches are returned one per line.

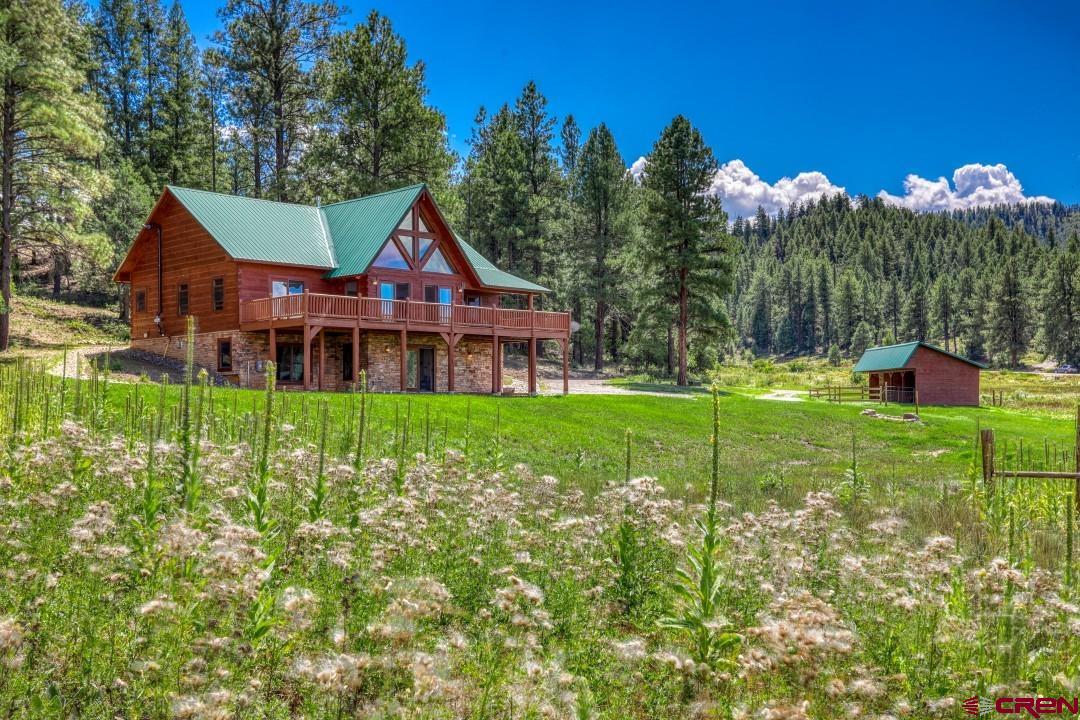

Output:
xmin=0 ymin=359 xmax=1080 ymax=719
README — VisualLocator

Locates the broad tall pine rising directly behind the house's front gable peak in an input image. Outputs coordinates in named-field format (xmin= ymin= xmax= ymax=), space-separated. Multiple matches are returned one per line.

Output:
xmin=308 ymin=11 xmax=454 ymax=200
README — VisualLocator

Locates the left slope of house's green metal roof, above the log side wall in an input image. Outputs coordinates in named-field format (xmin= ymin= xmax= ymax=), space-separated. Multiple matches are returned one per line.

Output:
xmin=168 ymin=186 xmax=337 ymax=268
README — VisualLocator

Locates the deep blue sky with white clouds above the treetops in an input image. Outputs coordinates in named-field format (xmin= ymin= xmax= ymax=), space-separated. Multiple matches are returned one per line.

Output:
xmin=168 ymin=0 xmax=1080 ymax=209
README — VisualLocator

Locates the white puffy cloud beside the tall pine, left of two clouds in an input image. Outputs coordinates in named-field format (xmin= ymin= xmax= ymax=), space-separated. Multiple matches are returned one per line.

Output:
xmin=710 ymin=159 xmax=847 ymax=218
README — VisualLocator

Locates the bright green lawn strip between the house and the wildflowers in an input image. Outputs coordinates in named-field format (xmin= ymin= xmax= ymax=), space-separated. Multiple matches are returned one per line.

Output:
xmin=90 ymin=375 xmax=1074 ymax=531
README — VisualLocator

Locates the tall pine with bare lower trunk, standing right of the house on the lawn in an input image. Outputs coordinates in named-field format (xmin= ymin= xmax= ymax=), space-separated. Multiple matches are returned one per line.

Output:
xmin=638 ymin=116 xmax=732 ymax=385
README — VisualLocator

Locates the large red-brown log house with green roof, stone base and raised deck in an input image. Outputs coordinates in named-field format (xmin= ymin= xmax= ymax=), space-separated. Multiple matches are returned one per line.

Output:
xmin=114 ymin=185 xmax=570 ymax=393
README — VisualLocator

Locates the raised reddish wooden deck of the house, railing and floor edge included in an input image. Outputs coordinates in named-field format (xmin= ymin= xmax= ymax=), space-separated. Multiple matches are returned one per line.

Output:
xmin=240 ymin=293 xmax=570 ymax=340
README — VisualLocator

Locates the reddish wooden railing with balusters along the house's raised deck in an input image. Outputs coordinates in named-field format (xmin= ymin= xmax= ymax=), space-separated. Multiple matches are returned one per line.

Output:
xmin=240 ymin=293 xmax=570 ymax=332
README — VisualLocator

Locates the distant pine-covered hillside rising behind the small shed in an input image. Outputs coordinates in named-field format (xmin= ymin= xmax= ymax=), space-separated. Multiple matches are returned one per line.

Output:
xmin=732 ymin=195 xmax=1080 ymax=366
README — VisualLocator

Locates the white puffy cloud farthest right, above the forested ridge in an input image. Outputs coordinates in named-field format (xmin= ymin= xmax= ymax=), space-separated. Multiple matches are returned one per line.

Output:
xmin=878 ymin=163 xmax=1054 ymax=213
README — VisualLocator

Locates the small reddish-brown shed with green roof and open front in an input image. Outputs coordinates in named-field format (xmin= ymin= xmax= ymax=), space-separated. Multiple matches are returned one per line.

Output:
xmin=854 ymin=341 xmax=986 ymax=406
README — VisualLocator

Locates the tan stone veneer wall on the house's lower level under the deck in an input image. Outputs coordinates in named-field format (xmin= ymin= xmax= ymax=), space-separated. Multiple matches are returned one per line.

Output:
xmin=132 ymin=329 xmax=491 ymax=393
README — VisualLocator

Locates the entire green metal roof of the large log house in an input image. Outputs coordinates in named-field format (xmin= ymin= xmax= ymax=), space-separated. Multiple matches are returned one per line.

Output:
xmin=168 ymin=185 xmax=548 ymax=293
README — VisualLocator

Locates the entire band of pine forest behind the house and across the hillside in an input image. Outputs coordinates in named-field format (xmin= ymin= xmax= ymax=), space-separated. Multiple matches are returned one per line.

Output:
xmin=0 ymin=0 xmax=1080 ymax=371
